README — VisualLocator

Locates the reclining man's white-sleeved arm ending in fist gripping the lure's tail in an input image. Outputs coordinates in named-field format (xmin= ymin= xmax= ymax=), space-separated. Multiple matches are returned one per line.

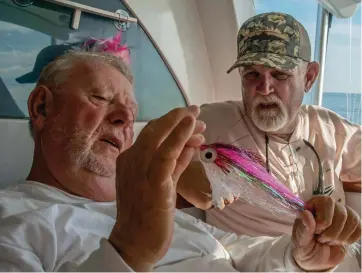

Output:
xmin=204 ymin=196 xmax=361 ymax=272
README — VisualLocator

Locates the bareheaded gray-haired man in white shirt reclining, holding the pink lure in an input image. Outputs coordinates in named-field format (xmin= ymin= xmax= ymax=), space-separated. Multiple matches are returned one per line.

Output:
xmin=0 ymin=49 xmax=360 ymax=271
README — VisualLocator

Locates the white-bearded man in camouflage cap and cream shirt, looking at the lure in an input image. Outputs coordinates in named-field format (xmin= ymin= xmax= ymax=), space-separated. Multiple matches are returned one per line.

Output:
xmin=178 ymin=12 xmax=361 ymax=268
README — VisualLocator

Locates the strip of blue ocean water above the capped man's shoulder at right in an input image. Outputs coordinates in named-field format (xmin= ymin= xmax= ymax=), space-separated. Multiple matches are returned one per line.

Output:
xmin=322 ymin=92 xmax=362 ymax=125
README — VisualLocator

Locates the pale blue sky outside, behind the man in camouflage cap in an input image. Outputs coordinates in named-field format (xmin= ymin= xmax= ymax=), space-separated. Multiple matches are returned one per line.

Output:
xmin=255 ymin=0 xmax=361 ymax=93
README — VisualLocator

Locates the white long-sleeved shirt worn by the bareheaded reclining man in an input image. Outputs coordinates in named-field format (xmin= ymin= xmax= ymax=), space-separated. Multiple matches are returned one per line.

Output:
xmin=0 ymin=181 xmax=300 ymax=272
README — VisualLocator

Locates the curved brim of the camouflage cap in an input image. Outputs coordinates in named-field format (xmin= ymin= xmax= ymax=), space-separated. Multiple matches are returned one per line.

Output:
xmin=227 ymin=52 xmax=303 ymax=73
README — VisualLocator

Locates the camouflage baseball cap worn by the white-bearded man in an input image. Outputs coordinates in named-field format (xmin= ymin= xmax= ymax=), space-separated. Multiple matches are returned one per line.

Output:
xmin=227 ymin=12 xmax=311 ymax=73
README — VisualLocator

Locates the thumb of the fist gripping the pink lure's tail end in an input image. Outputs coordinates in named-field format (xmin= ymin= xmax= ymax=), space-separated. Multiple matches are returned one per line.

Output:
xmin=293 ymin=210 xmax=316 ymax=248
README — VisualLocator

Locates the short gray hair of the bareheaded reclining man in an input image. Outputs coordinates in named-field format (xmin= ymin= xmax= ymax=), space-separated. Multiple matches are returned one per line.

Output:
xmin=29 ymin=50 xmax=133 ymax=138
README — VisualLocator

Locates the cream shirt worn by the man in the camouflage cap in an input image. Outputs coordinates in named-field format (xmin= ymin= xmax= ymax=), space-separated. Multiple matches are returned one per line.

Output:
xmin=199 ymin=101 xmax=361 ymax=236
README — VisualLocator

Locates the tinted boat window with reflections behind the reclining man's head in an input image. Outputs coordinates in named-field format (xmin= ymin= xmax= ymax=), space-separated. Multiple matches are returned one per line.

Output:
xmin=0 ymin=0 xmax=187 ymax=121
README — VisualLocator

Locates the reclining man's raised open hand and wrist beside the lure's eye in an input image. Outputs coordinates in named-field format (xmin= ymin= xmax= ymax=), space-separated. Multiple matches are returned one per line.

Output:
xmin=108 ymin=106 xmax=205 ymax=271
